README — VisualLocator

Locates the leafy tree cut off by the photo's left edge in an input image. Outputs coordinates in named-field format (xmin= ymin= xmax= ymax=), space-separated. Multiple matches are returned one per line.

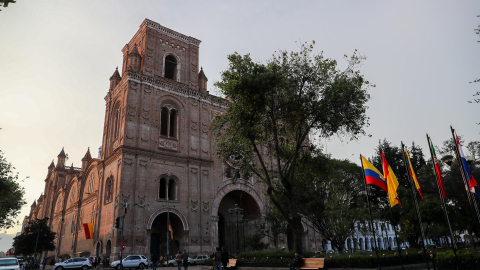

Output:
xmin=0 ymin=151 xmax=27 ymax=229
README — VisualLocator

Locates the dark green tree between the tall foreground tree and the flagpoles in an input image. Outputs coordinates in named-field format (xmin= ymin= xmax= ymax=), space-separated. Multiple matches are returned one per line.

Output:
xmin=299 ymin=157 xmax=367 ymax=251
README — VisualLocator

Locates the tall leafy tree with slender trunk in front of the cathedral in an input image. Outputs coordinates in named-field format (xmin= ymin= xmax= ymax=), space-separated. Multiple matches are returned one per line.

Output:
xmin=214 ymin=43 xmax=370 ymax=254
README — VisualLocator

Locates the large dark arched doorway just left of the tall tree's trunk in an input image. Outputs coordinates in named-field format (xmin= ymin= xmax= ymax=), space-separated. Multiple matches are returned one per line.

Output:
xmin=217 ymin=190 xmax=262 ymax=253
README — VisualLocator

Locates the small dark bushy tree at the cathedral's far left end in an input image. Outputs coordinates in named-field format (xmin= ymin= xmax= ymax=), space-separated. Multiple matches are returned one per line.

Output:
xmin=13 ymin=217 xmax=56 ymax=255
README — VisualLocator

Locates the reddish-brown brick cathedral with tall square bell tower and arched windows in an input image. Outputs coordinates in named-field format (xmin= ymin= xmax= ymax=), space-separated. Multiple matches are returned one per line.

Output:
xmin=24 ymin=19 xmax=322 ymax=261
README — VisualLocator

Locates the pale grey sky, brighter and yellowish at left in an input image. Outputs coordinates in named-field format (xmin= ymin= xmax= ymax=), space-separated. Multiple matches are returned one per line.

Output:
xmin=0 ymin=0 xmax=480 ymax=251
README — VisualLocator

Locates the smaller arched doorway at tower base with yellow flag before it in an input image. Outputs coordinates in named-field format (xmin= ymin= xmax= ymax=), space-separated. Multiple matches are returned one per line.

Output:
xmin=150 ymin=212 xmax=185 ymax=255
